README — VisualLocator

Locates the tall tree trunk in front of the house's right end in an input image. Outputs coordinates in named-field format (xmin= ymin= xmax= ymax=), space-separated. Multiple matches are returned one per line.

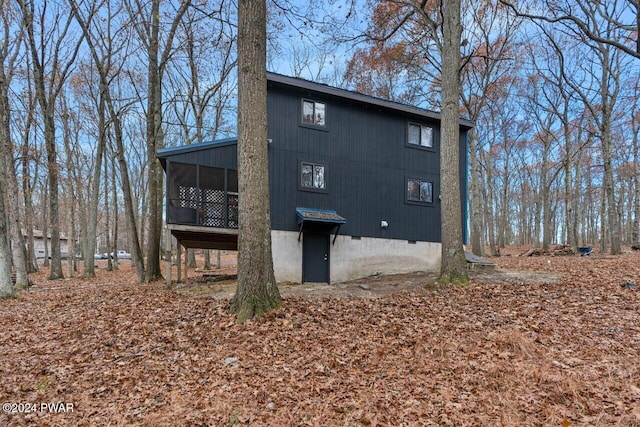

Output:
xmin=440 ymin=0 xmax=469 ymax=284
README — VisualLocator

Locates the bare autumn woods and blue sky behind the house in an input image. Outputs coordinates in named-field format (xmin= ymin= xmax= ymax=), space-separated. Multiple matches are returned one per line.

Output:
xmin=0 ymin=0 xmax=640 ymax=286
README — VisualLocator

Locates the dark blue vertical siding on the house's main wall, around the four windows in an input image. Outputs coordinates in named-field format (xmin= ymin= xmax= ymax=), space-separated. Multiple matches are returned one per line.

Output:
xmin=268 ymin=84 xmax=466 ymax=242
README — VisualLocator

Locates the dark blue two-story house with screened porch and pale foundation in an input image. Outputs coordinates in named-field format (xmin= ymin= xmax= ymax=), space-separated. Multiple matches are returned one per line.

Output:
xmin=158 ymin=73 xmax=473 ymax=283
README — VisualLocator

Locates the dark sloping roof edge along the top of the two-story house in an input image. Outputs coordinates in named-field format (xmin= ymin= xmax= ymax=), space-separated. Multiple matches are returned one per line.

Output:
xmin=267 ymin=72 xmax=474 ymax=128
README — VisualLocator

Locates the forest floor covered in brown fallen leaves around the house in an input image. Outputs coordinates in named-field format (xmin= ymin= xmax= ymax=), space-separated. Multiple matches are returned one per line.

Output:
xmin=0 ymin=248 xmax=640 ymax=426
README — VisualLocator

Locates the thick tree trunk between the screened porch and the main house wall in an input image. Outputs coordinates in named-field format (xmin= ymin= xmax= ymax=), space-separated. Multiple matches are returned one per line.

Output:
xmin=231 ymin=0 xmax=282 ymax=323
